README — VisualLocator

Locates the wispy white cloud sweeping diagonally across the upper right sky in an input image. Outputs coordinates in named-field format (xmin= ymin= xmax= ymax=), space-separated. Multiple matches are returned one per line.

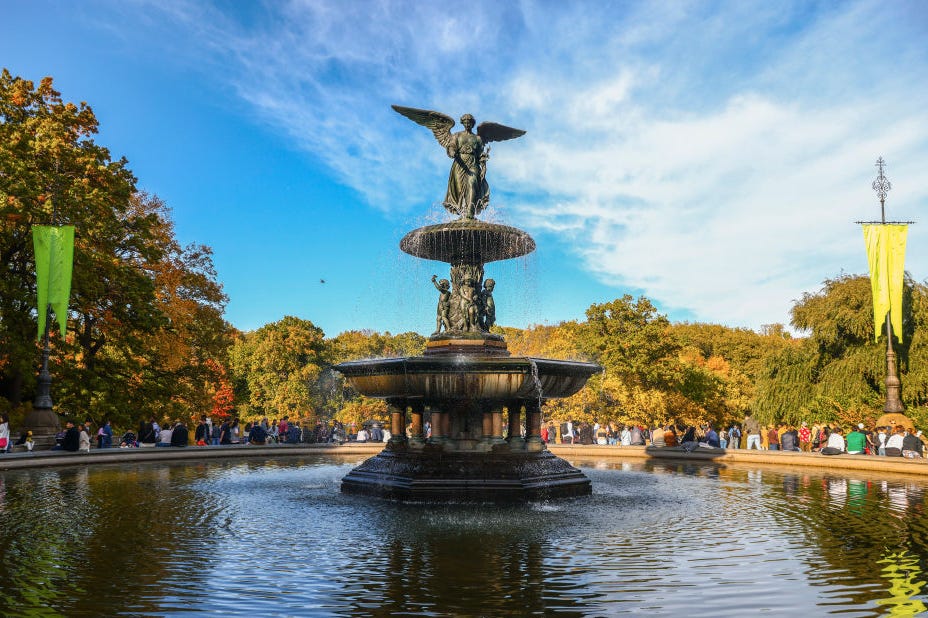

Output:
xmin=138 ymin=1 xmax=928 ymax=327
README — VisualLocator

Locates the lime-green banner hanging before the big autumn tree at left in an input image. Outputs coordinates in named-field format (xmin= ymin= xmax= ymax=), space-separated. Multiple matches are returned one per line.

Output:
xmin=32 ymin=225 xmax=74 ymax=339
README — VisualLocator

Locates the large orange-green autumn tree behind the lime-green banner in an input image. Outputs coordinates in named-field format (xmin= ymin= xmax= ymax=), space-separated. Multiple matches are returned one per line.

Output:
xmin=0 ymin=70 xmax=230 ymax=424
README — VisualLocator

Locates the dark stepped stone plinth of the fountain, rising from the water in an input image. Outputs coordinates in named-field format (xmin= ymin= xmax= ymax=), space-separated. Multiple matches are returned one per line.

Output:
xmin=341 ymin=444 xmax=592 ymax=503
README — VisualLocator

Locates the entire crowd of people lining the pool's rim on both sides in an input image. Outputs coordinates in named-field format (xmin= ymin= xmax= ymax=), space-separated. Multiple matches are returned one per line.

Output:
xmin=0 ymin=415 xmax=925 ymax=458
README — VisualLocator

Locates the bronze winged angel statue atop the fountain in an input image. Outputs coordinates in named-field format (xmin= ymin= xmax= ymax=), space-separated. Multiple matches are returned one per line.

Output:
xmin=392 ymin=105 xmax=525 ymax=219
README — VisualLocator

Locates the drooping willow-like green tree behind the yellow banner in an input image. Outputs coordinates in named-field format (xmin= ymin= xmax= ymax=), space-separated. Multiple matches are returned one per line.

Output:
xmin=754 ymin=275 xmax=928 ymax=424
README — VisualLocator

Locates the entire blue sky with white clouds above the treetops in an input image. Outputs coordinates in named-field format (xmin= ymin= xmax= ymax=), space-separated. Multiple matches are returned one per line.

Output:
xmin=0 ymin=0 xmax=928 ymax=336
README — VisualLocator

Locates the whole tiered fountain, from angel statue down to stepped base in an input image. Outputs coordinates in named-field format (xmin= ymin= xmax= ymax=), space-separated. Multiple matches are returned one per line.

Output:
xmin=335 ymin=106 xmax=602 ymax=502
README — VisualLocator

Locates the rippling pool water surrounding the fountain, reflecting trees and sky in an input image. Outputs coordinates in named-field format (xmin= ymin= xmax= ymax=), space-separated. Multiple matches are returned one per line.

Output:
xmin=0 ymin=456 xmax=928 ymax=616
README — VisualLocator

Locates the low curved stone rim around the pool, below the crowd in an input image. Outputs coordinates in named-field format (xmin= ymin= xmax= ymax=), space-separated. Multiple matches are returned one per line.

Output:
xmin=0 ymin=442 xmax=928 ymax=476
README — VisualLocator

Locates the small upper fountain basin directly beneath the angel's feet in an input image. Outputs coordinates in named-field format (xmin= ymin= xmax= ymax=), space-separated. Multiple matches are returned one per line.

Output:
xmin=400 ymin=219 xmax=535 ymax=264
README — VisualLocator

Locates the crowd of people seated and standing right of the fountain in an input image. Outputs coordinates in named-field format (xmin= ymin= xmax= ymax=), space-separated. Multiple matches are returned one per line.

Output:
xmin=541 ymin=415 xmax=925 ymax=458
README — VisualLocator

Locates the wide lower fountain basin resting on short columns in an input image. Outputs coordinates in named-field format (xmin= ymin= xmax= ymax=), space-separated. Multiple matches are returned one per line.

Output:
xmin=335 ymin=354 xmax=602 ymax=400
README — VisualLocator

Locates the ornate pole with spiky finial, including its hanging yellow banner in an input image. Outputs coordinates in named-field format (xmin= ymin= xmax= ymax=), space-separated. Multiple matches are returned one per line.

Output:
xmin=857 ymin=157 xmax=914 ymax=413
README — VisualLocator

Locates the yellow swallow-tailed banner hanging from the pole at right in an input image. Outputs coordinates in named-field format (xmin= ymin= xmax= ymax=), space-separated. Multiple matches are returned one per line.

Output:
xmin=864 ymin=223 xmax=909 ymax=341
